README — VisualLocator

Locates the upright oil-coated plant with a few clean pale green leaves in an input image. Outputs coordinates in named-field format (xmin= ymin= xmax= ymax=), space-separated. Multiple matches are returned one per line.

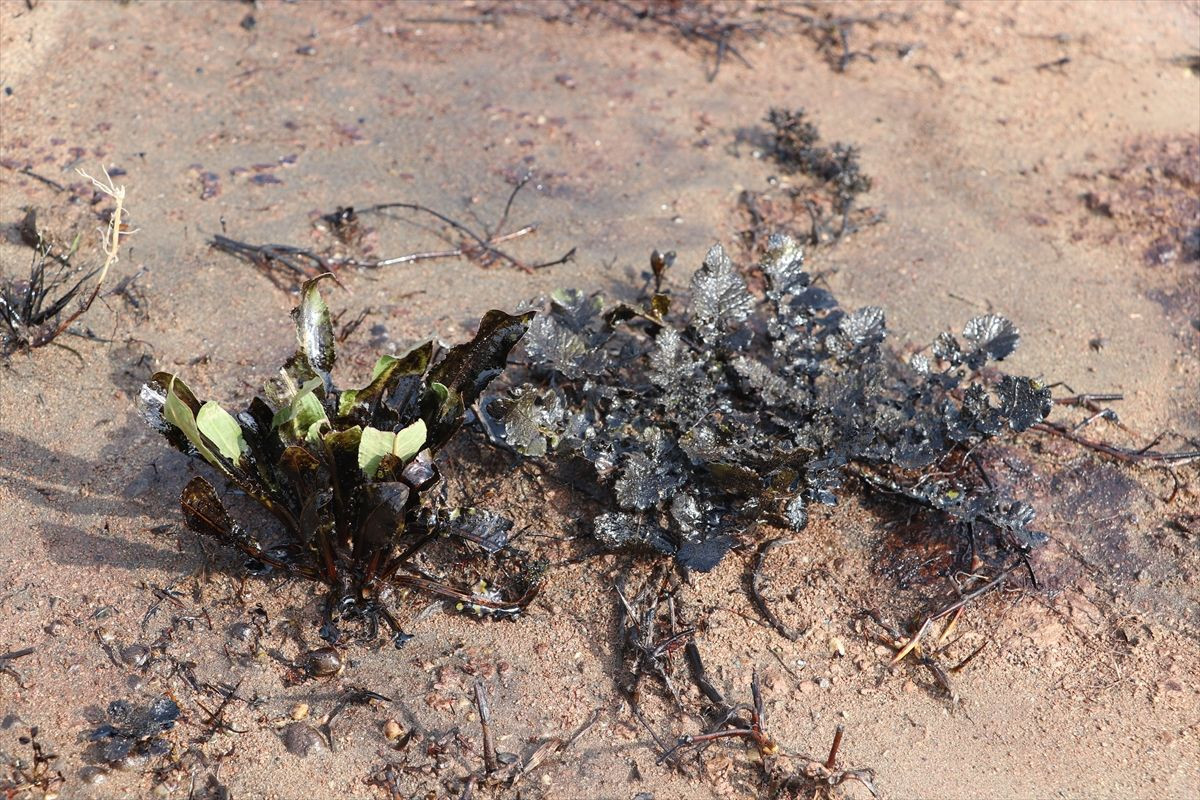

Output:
xmin=140 ymin=276 xmax=540 ymax=646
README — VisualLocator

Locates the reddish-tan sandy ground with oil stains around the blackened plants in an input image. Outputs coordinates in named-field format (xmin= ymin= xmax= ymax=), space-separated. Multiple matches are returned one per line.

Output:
xmin=0 ymin=0 xmax=1200 ymax=799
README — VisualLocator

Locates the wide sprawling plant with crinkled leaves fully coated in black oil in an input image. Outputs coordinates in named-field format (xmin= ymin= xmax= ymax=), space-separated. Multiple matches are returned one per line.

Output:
xmin=484 ymin=235 xmax=1051 ymax=571
